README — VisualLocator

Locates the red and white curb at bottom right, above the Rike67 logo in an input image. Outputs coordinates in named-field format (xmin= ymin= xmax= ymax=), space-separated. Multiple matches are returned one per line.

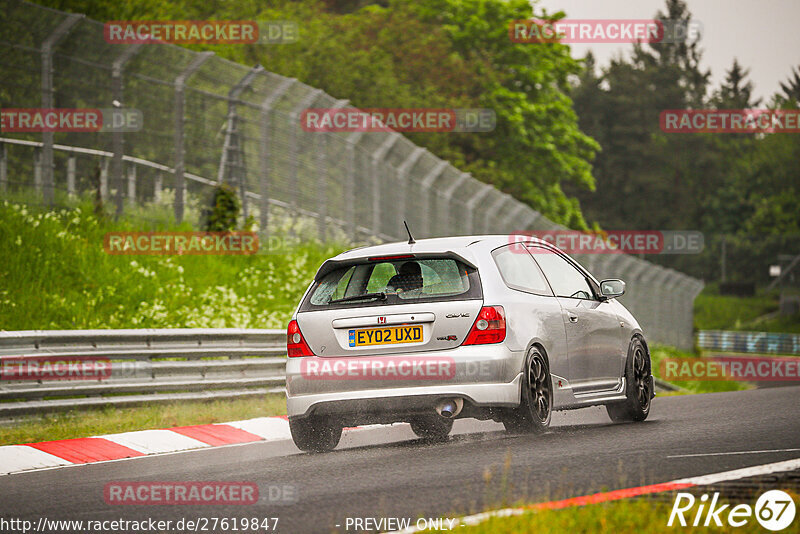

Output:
xmin=394 ymin=458 xmax=800 ymax=534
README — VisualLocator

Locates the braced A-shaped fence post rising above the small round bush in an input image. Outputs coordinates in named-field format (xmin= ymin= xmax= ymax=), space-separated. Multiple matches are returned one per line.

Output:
xmin=217 ymin=65 xmax=264 ymax=220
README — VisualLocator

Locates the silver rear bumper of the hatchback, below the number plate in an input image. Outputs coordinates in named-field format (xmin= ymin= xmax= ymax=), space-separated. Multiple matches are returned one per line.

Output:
xmin=286 ymin=343 xmax=525 ymax=421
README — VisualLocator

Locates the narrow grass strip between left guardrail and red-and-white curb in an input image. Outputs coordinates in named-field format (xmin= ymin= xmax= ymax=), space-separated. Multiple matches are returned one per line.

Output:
xmin=0 ymin=394 xmax=286 ymax=445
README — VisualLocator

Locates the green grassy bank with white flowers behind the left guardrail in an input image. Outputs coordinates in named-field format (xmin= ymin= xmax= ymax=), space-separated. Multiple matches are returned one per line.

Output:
xmin=0 ymin=197 xmax=346 ymax=330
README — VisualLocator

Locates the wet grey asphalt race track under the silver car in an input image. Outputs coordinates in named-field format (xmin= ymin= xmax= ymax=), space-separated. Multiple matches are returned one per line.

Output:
xmin=0 ymin=386 xmax=800 ymax=532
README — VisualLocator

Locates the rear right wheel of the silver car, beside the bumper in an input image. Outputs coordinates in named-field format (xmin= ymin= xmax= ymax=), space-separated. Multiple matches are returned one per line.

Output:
xmin=501 ymin=347 xmax=553 ymax=434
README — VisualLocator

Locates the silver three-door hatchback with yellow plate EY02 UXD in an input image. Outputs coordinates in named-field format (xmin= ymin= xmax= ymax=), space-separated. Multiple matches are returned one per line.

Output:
xmin=286 ymin=235 xmax=655 ymax=451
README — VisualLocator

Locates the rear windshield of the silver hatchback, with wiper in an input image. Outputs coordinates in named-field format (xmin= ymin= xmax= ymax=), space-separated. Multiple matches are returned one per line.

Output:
xmin=304 ymin=258 xmax=481 ymax=308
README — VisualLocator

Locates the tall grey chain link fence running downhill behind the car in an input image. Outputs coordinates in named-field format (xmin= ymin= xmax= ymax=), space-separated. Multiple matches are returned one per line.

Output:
xmin=0 ymin=0 xmax=703 ymax=348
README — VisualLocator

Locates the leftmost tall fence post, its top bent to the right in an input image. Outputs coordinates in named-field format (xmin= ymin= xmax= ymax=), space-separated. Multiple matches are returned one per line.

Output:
xmin=36 ymin=15 xmax=83 ymax=205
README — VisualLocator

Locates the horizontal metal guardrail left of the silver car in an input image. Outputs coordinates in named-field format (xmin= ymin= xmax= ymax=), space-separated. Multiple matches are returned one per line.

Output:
xmin=0 ymin=328 xmax=286 ymax=417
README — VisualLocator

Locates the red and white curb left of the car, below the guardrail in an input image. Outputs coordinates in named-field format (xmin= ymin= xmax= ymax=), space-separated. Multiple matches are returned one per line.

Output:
xmin=0 ymin=416 xmax=373 ymax=476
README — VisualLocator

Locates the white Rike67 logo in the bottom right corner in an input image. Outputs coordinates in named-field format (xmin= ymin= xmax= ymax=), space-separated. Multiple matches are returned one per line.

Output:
xmin=667 ymin=490 xmax=796 ymax=532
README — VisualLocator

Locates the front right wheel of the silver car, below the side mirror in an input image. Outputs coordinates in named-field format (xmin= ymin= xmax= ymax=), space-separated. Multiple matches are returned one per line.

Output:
xmin=606 ymin=336 xmax=654 ymax=423
